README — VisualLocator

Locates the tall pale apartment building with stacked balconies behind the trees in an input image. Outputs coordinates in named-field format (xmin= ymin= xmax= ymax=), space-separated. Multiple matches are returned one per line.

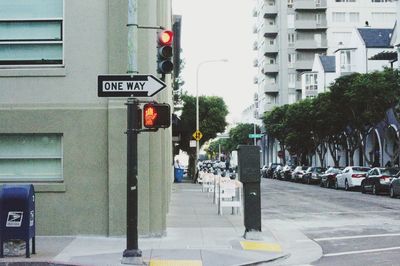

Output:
xmin=253 ymin=0 xmax=396 ymax=115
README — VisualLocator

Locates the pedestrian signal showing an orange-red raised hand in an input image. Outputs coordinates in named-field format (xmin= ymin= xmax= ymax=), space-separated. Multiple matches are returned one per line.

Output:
xmin=143 ymin=103 xmax=171 ymax=128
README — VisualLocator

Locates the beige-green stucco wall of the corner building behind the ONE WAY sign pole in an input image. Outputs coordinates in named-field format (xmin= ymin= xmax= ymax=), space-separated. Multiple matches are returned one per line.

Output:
xmin=0 ymin=0 xmax=172 ymax=236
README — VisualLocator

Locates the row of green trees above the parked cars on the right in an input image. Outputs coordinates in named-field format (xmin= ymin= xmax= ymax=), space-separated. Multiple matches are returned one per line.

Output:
xmin=263 ymin=69 xmax=400 ymax=165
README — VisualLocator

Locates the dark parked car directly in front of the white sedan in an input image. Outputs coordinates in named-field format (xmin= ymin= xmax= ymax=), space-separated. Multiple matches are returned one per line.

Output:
xmin=361 ymin=167 xmax=400 ymax=195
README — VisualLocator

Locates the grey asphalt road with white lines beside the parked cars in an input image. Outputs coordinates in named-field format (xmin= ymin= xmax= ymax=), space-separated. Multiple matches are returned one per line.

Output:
xmin=261 ymin=179 xmax=400 ymax=266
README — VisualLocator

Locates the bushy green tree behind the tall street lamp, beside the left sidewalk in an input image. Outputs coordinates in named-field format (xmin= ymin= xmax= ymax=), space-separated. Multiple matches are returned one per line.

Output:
xmin=178 ymin=94 xmax=228 ymax=176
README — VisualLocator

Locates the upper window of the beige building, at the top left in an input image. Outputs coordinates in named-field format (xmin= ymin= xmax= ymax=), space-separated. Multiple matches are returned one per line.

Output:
xmin=0 ymin=0 xmax=64 ymax=65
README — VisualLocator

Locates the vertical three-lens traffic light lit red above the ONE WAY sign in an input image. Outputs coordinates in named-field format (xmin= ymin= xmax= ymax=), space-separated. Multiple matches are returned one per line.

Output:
xmin=157 ymin=30 xmax=174 ymax=74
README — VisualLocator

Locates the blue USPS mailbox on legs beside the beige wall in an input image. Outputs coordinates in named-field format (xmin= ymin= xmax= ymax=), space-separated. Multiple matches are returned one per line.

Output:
xmin=0 ymin=185 xmax=35 ymax=258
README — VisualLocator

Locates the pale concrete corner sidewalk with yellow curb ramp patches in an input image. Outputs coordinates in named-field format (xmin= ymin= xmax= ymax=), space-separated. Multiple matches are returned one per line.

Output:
xmin=0 ymin=180 xmax=322 ymax=266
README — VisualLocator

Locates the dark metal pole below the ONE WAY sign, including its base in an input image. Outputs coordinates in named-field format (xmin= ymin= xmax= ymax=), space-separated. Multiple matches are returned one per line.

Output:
xmin=122 ymin=98 xmax=143 ymax=265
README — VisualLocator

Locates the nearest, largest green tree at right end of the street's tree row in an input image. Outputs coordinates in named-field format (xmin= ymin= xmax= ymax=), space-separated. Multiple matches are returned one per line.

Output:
xmin=331 ymin=69 xmax=399 ymax=165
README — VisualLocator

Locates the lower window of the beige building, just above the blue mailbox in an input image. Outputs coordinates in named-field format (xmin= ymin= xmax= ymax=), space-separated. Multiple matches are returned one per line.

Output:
xmin=0 ymin=134 xmax=63 ymax=182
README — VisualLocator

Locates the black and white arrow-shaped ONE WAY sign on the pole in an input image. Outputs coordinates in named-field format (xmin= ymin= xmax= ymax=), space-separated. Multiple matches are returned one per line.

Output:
xmin=97 ymin=75 xmax=166 ymax=97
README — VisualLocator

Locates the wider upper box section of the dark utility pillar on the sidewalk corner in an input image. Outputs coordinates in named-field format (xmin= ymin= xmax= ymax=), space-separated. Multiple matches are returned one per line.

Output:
xmin=237 ymin=145 xmax=261 ymax=183
